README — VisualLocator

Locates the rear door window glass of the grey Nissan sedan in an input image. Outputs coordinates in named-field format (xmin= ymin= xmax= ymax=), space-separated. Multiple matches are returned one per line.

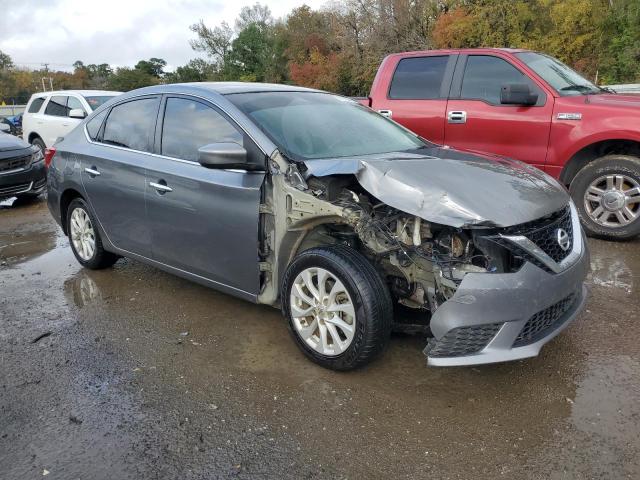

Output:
xmin=102 ymin=98 xmax=159 ymax=152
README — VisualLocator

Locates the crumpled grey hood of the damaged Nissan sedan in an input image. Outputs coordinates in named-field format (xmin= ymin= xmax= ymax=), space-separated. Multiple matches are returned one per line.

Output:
xmin=304 ymin=146 xmax=569 ymax=227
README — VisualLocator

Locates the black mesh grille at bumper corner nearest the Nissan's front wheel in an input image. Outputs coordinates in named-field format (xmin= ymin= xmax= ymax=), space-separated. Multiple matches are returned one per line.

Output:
xmin=425 ymin=323 xmax=503 ymax=357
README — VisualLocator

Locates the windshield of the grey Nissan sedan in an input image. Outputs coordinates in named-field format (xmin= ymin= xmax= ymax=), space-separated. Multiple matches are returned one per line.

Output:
xmin=227 ymin=92 xmax=425 ymax=160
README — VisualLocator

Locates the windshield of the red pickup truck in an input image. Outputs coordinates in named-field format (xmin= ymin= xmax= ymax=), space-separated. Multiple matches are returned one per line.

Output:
xmin=516 ymin=52 xmax=603 ymax=96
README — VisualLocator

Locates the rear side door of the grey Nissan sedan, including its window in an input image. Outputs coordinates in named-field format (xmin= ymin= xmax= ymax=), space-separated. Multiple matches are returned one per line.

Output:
xmin=81 ymin=95 xmax=161 ymax=258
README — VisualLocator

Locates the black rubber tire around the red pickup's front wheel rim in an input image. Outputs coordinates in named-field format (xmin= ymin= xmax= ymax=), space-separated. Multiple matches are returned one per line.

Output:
xmin=569 ymin=155 xmax=640 ymax=240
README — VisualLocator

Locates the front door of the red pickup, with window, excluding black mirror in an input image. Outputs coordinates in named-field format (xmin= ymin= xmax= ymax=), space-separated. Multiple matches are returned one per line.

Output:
xmin=444 ymin=54 xmax=553 ymax=168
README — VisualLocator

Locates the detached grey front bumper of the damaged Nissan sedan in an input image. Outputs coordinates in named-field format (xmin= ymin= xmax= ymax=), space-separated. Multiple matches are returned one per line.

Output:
xmin=424 ymin=215 xmax=590 ymax=366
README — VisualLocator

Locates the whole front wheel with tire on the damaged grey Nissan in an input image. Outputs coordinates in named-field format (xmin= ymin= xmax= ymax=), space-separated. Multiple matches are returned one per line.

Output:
xmin=282 ymin=245 xmax=393 ymax=370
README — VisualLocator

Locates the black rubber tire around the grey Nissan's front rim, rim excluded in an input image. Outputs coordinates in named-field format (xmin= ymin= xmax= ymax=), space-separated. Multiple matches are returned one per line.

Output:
xmin=281 ymin=245 xmax=393 ymax=370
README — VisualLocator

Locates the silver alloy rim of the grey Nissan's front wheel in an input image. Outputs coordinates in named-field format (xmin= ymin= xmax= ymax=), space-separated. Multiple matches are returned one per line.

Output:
xmin=289 ymin=268 xmax=356 ymax=356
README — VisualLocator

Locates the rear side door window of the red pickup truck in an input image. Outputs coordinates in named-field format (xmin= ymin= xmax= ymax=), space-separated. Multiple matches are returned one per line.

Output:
xmin=389 ymin=55 xmax=449 ymax=100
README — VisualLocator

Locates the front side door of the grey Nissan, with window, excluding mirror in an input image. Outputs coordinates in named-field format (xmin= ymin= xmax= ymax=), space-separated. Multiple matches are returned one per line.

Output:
xmin=146 ymin=96 xmax=264 ymax=295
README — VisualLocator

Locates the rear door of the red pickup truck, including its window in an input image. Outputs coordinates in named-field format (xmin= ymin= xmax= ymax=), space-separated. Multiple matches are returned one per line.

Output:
xmin=373 ymin=55 xmax=458 ymax=144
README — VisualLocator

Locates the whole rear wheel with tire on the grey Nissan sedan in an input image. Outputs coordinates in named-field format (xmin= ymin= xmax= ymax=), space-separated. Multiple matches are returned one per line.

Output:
xmin=67 ymin=198 xmax=118 ymax=270
